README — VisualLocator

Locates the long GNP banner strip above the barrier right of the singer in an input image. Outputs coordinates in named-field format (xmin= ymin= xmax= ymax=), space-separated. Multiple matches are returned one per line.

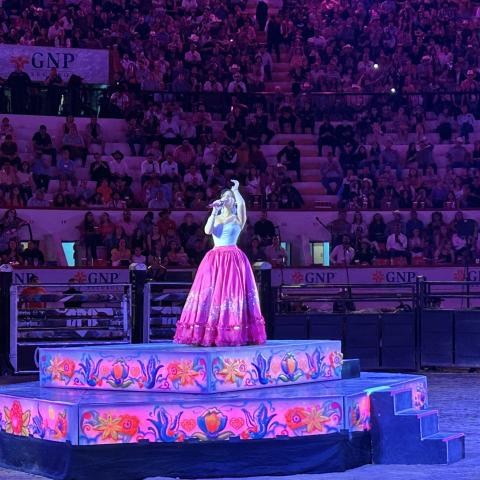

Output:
xmin=272 ymin=265 xmax=474 ymax=286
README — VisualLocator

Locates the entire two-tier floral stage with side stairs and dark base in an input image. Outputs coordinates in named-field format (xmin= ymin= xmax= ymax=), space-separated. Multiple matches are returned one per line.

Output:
xmin=0 ymin=341 xmax=464 ymax=480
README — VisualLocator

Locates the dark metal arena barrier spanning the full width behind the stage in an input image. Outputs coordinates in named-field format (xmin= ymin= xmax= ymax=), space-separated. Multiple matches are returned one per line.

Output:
xmin=0 ymin=265 xmax=480 ymax=374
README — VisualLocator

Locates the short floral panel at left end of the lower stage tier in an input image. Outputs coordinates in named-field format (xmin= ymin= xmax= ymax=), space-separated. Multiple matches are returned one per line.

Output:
xmin=0 ymin=396 xmax=76 ymax=443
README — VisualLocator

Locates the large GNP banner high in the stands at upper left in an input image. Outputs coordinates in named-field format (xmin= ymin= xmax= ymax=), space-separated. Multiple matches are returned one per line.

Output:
xmin=0 ymin=44 xmax=109 ymax=83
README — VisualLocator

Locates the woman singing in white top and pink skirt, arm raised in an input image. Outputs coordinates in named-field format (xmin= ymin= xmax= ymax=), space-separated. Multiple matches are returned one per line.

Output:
xmin=174 ymin=180 xmax=266 ymax=347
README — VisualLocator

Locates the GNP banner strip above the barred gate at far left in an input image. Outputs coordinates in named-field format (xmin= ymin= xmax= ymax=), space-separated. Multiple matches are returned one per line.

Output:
xmin=13 ymin=268 xmax=129 ymax=285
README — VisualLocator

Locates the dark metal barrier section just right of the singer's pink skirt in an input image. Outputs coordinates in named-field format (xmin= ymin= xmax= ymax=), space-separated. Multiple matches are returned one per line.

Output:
xmin=273 ymin=283 xmax=419 ymax=370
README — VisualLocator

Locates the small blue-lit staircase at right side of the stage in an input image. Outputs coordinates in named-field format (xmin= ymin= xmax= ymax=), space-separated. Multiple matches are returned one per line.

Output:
xmin=370 ymin=386 xmax=465 ymax=464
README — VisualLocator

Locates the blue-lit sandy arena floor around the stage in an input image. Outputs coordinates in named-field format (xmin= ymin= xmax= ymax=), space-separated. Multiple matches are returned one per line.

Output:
xmin=0 ymin=373 xmax=480 ymax=480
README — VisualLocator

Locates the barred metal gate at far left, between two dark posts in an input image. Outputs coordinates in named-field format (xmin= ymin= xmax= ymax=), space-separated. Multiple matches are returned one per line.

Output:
xmin=9 ymin=283 xmax=131 ymax=373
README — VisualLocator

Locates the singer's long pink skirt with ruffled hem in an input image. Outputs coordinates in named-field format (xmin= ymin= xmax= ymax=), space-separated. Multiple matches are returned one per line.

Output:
xmin=173 ymin=246 xmax=267 ymax=347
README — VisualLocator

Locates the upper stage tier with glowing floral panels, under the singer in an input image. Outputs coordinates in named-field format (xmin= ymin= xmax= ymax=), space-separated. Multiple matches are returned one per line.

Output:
xmin=39 ymin=340 xmax=343 ymax=394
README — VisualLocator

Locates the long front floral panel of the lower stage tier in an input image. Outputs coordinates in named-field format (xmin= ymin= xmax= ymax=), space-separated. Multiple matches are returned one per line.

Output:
xmin=79 ymin=398 xmax=343 ymax=445
